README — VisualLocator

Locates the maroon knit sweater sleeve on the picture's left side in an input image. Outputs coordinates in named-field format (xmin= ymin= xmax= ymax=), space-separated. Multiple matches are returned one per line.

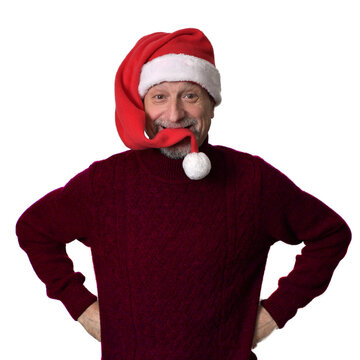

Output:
xmin=16 ymin=166 xmax=97 ymax=320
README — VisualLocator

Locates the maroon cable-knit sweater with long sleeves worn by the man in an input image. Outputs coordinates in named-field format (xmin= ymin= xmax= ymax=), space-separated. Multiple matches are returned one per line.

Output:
xmin=16 ymin=139 xmax=351 ymax=360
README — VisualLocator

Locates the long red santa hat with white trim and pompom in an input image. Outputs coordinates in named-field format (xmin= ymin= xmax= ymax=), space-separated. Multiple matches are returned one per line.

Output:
xmin=115 ymin=28 xmax=221 ymax=180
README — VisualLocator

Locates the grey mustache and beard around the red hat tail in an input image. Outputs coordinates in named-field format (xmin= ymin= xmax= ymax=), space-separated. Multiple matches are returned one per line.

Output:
xmin=154 ymin=118 xmax=200 ymax=159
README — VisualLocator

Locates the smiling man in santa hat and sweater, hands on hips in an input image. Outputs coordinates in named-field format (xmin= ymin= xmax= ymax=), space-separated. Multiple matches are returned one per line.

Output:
xmin=17 ymin=29 xmax=351 ymax=360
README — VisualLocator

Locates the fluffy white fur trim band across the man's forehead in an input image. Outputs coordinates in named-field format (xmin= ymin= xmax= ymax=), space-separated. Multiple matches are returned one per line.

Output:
xmin=138 ymin=54 xmax=221 ymax=105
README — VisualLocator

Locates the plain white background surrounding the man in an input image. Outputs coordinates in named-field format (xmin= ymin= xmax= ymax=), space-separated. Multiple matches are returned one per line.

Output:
xmin=0 ymin=0 xmax=360 ymax=360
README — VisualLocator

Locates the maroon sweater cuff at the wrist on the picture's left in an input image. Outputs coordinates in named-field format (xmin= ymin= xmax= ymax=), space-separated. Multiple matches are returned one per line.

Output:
xmin=59 ymin=284 xmax=97 ymax=320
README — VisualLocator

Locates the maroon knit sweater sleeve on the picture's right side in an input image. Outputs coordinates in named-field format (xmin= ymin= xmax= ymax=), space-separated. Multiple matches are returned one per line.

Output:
xmin=256 ymin=157 xmax=351 ymax=328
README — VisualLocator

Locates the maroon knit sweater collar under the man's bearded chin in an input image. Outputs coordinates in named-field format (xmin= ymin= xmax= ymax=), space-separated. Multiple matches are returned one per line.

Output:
xmin=135 ymin=136 xmax=212 ymax=183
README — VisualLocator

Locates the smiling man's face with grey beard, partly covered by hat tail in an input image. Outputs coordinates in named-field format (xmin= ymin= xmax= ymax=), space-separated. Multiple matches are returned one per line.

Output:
xmin=144 ymin=81 xmax=214 ymax=159
